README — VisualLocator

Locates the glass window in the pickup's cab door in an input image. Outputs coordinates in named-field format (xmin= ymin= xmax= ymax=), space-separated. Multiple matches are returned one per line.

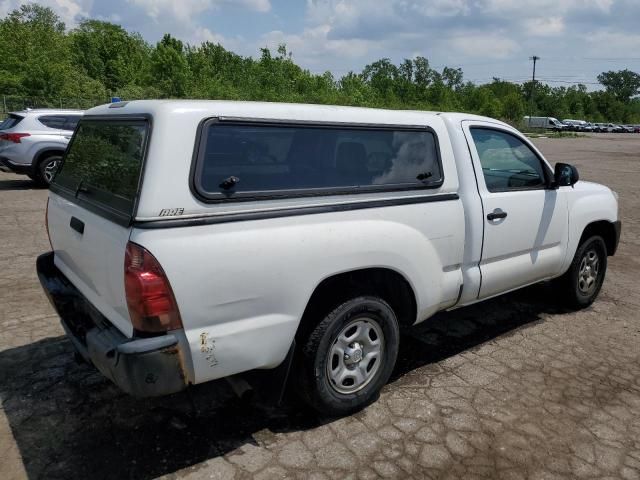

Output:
xmin=470 ymin=128 xmax=547 ymax=192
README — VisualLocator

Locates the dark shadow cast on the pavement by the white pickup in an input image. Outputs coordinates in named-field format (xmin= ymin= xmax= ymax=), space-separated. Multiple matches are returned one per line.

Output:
xmin=0 ymin=286 xmax=558 ymax=479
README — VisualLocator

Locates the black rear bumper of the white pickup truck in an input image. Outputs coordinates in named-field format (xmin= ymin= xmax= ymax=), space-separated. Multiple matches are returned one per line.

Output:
xmin=36 ymin=252 xmax=188 ymax=397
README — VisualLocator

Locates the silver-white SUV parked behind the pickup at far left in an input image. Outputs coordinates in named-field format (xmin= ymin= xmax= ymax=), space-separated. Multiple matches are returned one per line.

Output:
xmin=0 ymin=109 xmax=83 ymax=186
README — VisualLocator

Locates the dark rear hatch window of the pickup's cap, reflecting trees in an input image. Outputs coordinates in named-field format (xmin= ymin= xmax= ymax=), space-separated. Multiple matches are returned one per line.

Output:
xmin=51 ymin=118 xmax=149 ymax=225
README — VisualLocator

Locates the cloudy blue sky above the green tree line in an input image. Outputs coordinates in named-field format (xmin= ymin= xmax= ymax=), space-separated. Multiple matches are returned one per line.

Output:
xmin=0 ymin=0 xmax=640 ymax=90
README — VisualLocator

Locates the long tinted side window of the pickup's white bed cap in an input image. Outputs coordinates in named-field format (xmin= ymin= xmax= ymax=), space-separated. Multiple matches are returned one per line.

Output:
xmin=193 ymin=119 xmax=443 ymax=201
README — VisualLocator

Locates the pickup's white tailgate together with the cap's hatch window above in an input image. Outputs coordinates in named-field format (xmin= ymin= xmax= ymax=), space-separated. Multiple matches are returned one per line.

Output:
xmin=47 ymin=117 xmax=148 ymax=337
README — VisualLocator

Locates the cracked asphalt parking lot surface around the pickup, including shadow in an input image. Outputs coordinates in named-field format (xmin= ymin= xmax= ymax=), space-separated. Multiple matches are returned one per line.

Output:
xmin=0 ymin=135 xmax=640 ymax=480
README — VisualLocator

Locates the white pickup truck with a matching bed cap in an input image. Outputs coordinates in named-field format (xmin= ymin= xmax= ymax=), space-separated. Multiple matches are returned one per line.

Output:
xmin=37 ymin=101 xmax=620 ymax=415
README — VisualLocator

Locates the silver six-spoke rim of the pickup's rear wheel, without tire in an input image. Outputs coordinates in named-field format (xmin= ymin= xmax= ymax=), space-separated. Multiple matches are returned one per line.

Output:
xmin=326 ymin=317 xmax=384 ymax=395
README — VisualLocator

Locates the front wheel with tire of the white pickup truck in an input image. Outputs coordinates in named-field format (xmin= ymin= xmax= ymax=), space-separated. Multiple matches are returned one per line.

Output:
xmin=558 ymin=235 xmax=607 ymax=309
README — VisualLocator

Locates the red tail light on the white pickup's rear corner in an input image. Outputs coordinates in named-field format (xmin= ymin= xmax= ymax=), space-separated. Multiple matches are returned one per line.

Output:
xmin=124 ymin=242 xmax=182 ymax=333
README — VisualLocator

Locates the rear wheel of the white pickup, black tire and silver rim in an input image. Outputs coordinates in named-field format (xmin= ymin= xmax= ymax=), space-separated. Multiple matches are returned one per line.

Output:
xmin=298 ymin=296 xmax=400 ymax=416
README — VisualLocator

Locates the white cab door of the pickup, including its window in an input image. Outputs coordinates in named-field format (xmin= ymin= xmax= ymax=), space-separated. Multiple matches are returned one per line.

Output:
xmin=463 ymin=122 xmax=568 ymax=298
